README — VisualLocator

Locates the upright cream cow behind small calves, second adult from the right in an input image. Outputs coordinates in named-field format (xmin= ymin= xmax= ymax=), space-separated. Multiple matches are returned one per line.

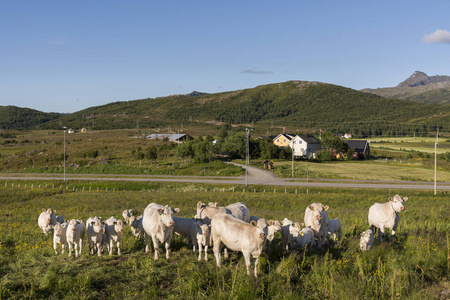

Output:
xmin=305 ymin=203 xmax=328 ymax=249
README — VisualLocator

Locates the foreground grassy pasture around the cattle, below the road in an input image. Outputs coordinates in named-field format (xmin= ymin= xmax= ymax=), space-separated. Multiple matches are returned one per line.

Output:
xmin=0 ymin=182 xmax=450 ymax=299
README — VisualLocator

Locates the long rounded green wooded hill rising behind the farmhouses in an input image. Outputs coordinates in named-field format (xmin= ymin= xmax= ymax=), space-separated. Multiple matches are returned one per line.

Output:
xmin=3 ymin=81 xmax=450 ymax=135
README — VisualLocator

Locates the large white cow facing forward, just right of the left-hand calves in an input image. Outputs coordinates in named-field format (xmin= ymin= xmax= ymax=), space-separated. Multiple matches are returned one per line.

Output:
xmin=142 ymin=203 xmax=180 ymax=259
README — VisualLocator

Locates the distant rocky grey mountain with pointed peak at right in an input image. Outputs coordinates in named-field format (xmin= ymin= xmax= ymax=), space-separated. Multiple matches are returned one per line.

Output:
xmin=361 ymin=71 xmax=450 ymax=104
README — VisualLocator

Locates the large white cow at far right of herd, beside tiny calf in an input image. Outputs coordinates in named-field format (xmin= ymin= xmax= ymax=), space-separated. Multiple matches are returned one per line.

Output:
xmin=369 ymin=195 xmax=408 ymax=241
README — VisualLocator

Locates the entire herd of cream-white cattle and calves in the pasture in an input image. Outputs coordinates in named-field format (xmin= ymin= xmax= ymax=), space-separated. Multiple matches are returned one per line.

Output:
xmin=38 ymin=195 xmax=408 ymax=276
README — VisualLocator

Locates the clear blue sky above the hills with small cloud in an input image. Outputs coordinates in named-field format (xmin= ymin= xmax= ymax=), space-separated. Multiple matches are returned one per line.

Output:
xmin=0 ymin=0 xmax=450 ymax=113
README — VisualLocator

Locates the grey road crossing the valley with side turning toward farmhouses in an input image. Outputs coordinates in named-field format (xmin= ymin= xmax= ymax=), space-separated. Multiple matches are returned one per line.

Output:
xmin=0 ymin=163 xmax=450 ymax=190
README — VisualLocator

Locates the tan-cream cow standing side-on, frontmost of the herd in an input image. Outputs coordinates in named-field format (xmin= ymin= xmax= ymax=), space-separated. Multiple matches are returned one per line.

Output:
xmin=211 ymin=214 xmax=267 ymax=277
